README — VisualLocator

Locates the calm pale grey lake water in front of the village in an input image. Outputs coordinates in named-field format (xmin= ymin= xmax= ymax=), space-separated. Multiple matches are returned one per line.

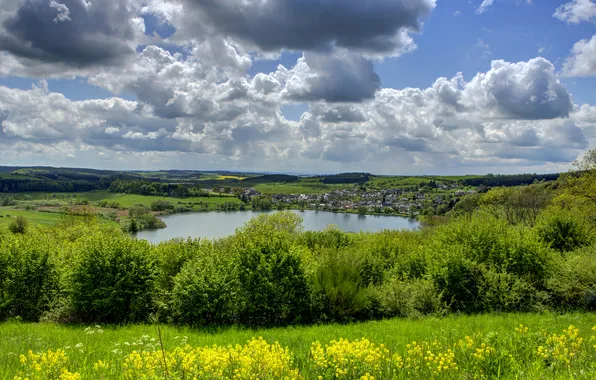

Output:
xmin=136 ymin=210 xmax=419 ymax=243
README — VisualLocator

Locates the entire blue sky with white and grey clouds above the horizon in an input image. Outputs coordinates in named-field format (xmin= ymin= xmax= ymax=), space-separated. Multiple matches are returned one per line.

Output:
xmin=0 ymin=0 xmax=596 ymax=175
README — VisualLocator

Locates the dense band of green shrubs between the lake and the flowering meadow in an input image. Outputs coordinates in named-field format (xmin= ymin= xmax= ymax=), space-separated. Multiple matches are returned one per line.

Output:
xmin=0 ymin=191 xmax=596 ymax=326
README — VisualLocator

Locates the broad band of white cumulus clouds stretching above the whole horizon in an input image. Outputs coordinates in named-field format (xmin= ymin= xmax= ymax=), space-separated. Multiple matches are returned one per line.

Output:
xmin=0 ymin=46 xmax=596 ymax=173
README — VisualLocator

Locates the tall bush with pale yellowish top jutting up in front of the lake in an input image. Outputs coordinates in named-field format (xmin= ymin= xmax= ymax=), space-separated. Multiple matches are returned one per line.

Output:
xmin=234 ymin=212 xmax=309 ymax=326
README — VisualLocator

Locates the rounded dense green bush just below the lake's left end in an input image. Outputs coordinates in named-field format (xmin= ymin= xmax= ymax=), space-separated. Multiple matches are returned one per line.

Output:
xmin=70 ymin=233 xmax=156 ymax=323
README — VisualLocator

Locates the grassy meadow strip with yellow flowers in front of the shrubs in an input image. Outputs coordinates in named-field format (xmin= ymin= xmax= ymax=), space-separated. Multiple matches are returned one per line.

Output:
xmin=0 ymin=313 xmax=596 ymax=379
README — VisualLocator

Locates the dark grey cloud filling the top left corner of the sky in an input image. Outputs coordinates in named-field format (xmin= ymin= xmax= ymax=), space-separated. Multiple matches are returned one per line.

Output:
xmin=0 ymin=0 xmax=144 ymax=68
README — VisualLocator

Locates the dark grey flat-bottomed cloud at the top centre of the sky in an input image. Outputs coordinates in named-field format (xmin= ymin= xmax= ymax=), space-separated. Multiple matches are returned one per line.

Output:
xmin=185 ymin=0 xmax=436 ymax=56
